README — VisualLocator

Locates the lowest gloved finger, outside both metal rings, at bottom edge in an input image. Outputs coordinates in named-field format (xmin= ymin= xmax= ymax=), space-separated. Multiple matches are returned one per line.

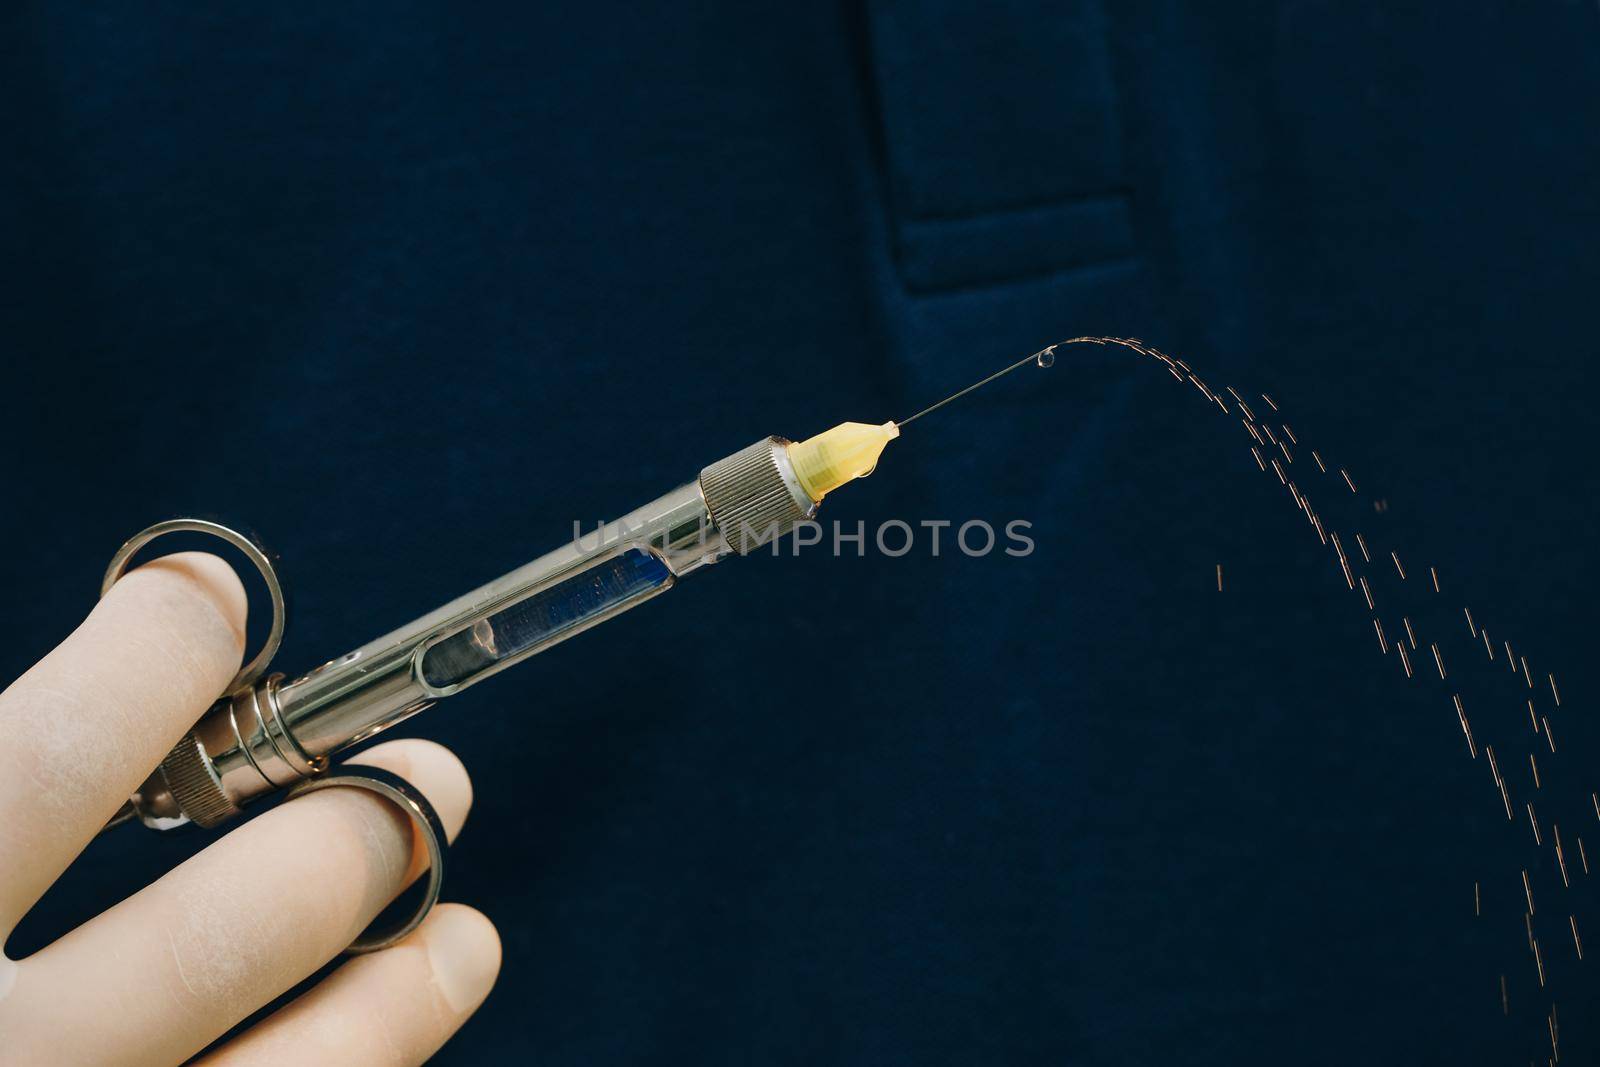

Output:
xmin=198 ymin=904 xmax=501 ymax=1067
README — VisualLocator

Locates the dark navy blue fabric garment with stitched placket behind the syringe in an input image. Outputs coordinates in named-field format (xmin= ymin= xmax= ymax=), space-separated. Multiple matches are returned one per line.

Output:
xmin=0 ymin=0 xmax=1600 ymax=1064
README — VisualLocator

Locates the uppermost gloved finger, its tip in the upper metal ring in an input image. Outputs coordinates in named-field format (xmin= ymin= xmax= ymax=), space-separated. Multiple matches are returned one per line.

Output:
xmin=0 ymin=552 xmax=245 ymax=944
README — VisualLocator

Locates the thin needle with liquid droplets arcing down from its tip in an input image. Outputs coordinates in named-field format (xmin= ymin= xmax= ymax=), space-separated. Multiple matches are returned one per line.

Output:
xmin=998 ymin=336 xmax=1600 ymax=1062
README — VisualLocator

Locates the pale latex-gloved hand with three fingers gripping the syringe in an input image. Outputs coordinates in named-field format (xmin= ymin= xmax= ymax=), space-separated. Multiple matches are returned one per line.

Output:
xmin=0 ymin=553 xmax=499 ymax=1065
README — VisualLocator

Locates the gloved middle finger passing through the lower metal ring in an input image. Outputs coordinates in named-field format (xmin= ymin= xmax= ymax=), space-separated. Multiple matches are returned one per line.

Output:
xmin=5 ymin=741 xmax=472 ymax=1064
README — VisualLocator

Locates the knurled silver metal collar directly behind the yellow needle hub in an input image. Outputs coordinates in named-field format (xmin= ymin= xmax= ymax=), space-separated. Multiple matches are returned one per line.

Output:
xmin=701 ymin=437 xmax=816 ymax=555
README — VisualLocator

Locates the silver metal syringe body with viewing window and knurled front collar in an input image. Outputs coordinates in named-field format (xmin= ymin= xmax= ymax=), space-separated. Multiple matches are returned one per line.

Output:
xmin=131 ymin=438 xmax=816 ymax=829
